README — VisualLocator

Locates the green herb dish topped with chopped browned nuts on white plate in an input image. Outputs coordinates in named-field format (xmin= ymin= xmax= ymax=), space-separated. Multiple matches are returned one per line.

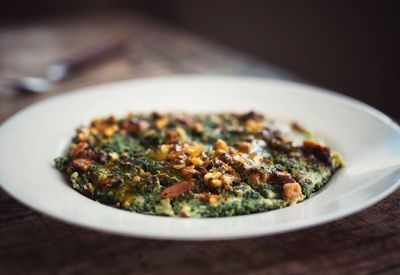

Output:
xmin=55 ymin=112 xmax=343 ymax=217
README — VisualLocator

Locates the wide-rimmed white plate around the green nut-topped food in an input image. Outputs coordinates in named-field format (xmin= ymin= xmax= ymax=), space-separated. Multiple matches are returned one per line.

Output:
xmin=0 ymin=76 xmax=400 ymax=240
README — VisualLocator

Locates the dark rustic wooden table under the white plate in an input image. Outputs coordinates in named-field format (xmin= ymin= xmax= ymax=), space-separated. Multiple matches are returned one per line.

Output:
xmin=0 ymin=11 xmax=400 ymax=274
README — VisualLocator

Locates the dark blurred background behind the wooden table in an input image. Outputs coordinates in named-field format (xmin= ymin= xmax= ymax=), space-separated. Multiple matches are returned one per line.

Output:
xmin=0 ymin=0 xmax=400 ymax=117
